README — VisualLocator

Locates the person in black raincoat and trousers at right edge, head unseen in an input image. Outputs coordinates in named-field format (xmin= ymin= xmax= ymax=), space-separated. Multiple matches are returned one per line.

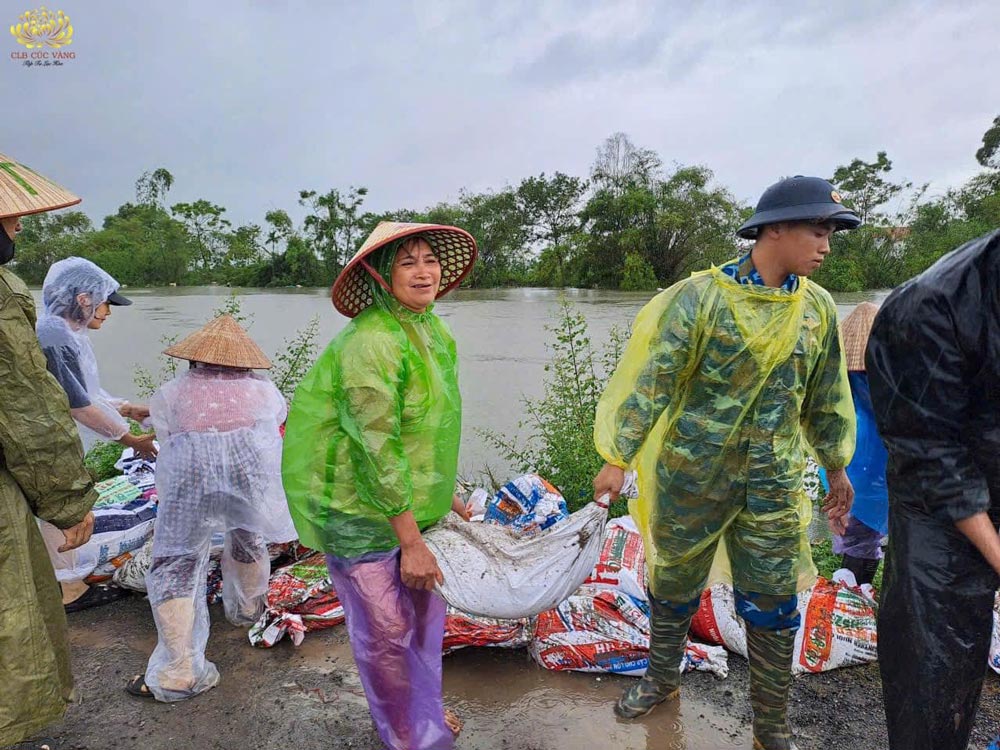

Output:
xmin=866 ymin=231 xmax=1000 ymax=750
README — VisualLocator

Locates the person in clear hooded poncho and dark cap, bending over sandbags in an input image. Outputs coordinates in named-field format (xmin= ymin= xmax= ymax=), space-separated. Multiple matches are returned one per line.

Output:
xmin=36 ymin=258 xmax=156 ymax=612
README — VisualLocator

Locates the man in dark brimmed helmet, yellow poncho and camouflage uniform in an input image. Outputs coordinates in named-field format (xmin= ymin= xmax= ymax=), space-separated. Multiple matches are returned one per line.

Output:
xmin=594 ymin=177 xmax=860 ymax=750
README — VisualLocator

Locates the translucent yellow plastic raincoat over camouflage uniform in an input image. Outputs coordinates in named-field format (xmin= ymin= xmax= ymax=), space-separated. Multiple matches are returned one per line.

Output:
xmin=594 ymin=268 xmax=855 ymax=602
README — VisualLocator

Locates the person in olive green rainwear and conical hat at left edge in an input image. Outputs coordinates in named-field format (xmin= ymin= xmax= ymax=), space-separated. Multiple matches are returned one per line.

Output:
xmin=0 ymin=154 xmax=97 ymax=747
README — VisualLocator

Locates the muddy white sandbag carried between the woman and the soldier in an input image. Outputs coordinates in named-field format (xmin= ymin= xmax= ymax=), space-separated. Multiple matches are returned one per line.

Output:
xmin=424 ymin=497 xmax=608 ymax=619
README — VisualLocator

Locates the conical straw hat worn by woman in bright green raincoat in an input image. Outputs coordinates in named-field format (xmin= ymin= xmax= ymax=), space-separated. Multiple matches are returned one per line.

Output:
xmin=330 ymin=221 xmax=477 ymax=318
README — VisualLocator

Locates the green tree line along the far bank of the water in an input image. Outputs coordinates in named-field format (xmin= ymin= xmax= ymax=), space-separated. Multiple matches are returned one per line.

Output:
xmin=9 ymin=117 xmax=1000 ymax=291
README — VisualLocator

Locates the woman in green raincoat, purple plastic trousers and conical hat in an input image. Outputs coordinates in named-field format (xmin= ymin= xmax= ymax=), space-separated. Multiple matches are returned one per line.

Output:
xmin=282 ymin=223 xmax=476 ymax=750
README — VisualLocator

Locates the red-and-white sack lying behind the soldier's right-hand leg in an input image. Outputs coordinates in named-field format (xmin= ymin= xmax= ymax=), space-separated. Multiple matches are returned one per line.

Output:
xmin=691 ymin=570 xmax=878 ymax=674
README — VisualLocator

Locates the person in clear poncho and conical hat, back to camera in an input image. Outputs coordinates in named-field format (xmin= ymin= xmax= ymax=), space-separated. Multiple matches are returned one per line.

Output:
xmin=126 ymin=315 xmax=295 ymax=702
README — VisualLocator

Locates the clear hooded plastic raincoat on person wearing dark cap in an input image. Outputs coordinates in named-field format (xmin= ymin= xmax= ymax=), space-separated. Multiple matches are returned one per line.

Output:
xmin=36 ymin=258 xmax=128 ymax=448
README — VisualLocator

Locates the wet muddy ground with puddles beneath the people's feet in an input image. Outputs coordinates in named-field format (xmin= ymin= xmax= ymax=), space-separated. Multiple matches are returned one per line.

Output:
xmin=17 ymin=596 xmax=1000 ymax=750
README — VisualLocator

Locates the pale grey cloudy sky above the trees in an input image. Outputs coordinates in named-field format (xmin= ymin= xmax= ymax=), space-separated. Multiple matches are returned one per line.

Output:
xmin=0 ymin=0 xmax=1000 ymax=229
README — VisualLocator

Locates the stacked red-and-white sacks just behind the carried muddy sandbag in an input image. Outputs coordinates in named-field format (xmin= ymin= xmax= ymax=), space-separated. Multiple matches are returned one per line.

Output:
xmin=528 ymin=518 xmax=729 ymax=677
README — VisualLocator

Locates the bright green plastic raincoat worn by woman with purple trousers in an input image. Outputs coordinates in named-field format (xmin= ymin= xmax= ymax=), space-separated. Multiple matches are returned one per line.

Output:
xmin=282 ymin=274 xmax=462 ymax=557
